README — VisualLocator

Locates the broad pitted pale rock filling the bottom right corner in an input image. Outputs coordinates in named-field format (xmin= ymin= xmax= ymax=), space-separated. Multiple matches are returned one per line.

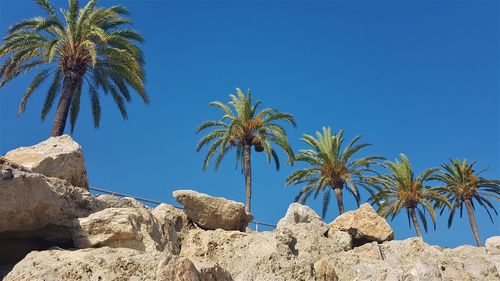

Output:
xmin=329 ymin=238 xmax=500 ymax=281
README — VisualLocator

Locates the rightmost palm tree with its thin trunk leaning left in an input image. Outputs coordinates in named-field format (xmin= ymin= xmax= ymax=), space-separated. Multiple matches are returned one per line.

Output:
xmin=434 ymin=160 xmax=500 ymax=247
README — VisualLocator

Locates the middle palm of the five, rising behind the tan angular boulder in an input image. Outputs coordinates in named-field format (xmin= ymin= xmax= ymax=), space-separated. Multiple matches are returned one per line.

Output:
xmin=285 ymin=128 xmax=384 ymax=218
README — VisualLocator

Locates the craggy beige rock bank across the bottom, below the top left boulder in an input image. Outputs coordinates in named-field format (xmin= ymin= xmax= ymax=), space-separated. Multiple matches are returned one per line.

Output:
xmin=0 ymin=138 xmax=500 ymax=281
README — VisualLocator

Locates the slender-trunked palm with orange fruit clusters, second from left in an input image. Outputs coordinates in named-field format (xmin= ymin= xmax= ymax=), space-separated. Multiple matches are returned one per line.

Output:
xmin=196 ymin=88 xmax=296 ymax=212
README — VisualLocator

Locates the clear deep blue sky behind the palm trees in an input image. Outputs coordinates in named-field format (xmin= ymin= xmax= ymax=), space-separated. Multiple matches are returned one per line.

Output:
xmin=0 ymin=0 xmax=500 ymax=247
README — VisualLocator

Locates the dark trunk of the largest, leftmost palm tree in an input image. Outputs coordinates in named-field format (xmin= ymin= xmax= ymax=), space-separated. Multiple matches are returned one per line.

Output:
xmin=50 ymin=71 xmax=80 ymax=137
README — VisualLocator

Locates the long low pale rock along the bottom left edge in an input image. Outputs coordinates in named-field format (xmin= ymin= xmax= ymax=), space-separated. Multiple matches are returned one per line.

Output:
xmin=4 ymin=247 xmax=202 ymax=281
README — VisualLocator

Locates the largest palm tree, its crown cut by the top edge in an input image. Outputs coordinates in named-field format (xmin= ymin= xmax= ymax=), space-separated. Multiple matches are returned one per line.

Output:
xmin=0 ymin=0 xmax=149 ymax=136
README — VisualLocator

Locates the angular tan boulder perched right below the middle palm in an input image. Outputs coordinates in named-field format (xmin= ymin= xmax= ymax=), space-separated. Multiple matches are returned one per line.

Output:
xmin=329 ymin=204 xmax=394 ymax=245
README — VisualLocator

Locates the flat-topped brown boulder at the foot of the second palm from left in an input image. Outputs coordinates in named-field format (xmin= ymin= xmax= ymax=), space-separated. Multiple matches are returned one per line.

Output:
xmin=173 ymin=190 xmax=253 ymax=231
